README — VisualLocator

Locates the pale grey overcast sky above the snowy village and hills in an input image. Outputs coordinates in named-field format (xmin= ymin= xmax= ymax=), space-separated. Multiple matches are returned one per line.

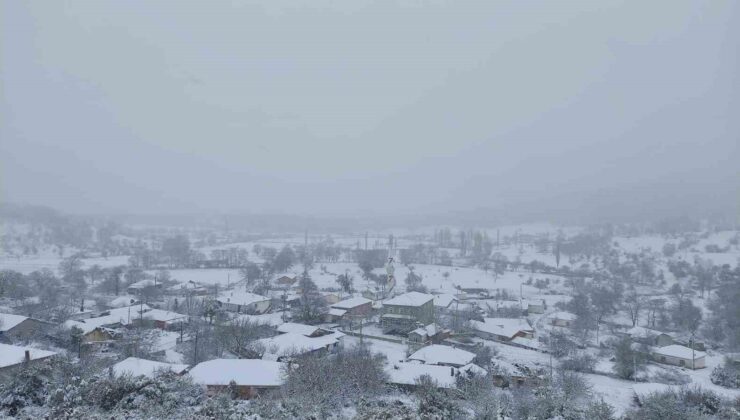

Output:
xmin=0 ymin=0 xmax=740 ymax=220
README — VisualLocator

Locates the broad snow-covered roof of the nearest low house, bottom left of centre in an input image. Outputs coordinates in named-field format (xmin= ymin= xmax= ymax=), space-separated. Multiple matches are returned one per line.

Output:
xmin=190 ymin=359 xmax=283 ymax=387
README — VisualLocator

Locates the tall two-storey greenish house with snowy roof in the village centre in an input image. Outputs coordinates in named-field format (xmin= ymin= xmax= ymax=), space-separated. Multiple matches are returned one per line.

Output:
xmin=380 ymin=292 xmax=434 ymax=334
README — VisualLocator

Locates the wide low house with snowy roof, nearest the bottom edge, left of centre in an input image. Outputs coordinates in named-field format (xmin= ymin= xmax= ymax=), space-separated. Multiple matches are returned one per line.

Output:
xmin=189 ymin=359 xmax=284 ymax=399
